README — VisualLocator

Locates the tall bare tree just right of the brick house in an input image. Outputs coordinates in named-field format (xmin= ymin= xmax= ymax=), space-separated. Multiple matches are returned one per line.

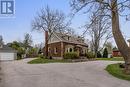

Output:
xmin=84 ymin=12 xmax=112 ymax=57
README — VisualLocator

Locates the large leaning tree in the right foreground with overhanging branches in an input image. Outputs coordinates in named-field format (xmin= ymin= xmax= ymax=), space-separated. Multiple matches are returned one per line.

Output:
xmin=71 ymin=0 xmax=130 ymax=74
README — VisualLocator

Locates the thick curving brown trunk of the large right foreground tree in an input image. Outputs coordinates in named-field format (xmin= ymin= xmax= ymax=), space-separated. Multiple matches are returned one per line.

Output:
xmin=111 ymin=0 xmax=130 ymax=74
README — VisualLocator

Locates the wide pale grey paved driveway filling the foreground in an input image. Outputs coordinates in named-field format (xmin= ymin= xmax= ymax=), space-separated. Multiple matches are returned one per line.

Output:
xmin=0 ymin=59 xmax=130 ymax=87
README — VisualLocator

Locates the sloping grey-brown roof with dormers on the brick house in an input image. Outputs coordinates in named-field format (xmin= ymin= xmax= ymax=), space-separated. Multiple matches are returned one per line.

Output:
xmin=55 ymin=32 xmax=88 ymax=46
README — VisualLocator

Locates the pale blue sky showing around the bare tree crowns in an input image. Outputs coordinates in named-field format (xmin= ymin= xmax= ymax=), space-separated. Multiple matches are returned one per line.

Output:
xmin=0 ymin=0 xmax=130 ymax=44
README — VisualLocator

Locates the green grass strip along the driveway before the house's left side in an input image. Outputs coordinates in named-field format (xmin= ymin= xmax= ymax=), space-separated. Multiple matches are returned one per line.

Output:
xmin=28 ymin=58 xmax=70 ymax=64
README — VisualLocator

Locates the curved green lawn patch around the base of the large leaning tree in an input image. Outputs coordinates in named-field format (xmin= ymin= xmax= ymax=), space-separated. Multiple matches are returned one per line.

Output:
xmin=106 ymin=64 xmax=130 ymax=81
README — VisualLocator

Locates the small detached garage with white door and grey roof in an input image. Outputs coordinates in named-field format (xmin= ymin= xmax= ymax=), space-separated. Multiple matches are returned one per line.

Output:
xmin=0 ymin=45 xmax=17 ymax=61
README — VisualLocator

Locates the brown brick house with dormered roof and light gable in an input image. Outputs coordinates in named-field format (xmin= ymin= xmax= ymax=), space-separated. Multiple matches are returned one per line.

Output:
xmin=44 ymin=32 xmax=88 ymax=59
